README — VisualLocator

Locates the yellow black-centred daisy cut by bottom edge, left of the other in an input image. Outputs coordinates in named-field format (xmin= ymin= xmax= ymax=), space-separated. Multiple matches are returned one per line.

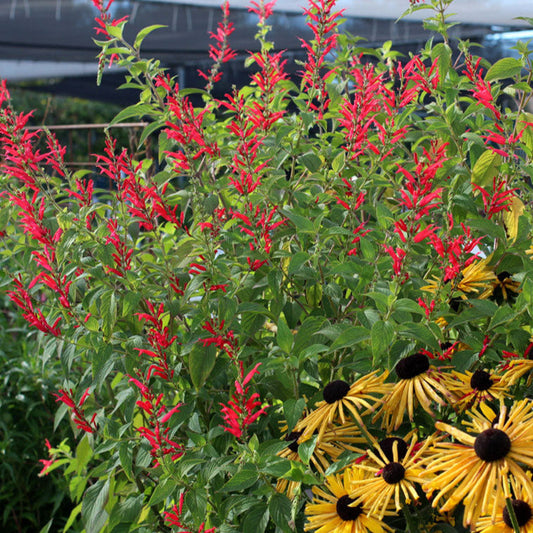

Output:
xmin=304 ymin=469 xmax=393 ymax=533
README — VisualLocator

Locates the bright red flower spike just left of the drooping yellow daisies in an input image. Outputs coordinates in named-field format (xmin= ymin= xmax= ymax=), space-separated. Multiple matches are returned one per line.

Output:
xmin=220 ymin=361 xmax=266 ymax=438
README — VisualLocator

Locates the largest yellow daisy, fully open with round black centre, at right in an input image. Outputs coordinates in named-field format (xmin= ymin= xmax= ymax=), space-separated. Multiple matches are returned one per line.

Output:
xmin=423 ymin=400 xmax=533 ymax=527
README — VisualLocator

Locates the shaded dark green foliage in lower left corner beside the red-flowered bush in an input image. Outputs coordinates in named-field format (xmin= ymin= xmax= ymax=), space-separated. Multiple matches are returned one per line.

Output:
xmin=0 ymin=290 xmax=74 ymax=533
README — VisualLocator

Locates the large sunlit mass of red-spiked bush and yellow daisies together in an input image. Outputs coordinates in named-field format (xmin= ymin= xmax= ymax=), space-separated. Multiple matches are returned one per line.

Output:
xmin=0 ymin=0 xmax=533 ymax=533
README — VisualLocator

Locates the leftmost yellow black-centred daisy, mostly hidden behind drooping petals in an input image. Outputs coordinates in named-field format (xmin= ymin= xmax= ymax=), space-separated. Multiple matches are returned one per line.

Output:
xmin=276 ymin=423 xmax=366 ymax=499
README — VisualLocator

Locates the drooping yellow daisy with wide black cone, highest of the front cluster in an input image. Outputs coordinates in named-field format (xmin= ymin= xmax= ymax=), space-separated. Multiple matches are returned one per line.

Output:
xmin=372 ymin=352 xmax=451 ymax=431
